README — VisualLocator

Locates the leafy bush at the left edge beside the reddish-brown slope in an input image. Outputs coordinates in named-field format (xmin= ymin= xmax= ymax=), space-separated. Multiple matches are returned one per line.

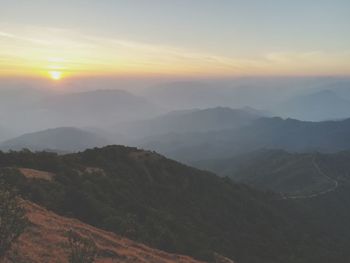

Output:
xmin=0 ymin=181 xmax=28 ymax=259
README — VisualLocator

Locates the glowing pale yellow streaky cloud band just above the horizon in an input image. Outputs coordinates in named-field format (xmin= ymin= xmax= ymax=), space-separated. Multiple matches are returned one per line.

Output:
xmin=0 ymin=25 xmax=350 ymax=75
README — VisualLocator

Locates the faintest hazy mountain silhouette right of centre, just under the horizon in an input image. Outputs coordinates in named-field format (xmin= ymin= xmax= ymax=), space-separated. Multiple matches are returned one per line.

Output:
xmin=142 ymin=77 xmax=309 ymax=110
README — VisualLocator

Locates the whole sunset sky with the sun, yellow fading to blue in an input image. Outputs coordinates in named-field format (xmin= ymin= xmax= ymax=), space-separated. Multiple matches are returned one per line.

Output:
xmin=0 ymin=0 xmax=350 ymax=80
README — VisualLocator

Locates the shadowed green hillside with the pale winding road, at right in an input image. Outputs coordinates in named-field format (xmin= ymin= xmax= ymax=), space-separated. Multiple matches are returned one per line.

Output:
xmin=197 ymin=150 xmax=350 ymax=255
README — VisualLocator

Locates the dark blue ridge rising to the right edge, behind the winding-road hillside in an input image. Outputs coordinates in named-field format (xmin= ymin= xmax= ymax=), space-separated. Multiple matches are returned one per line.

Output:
xmin=140 ymin=118 xmax=350 ymax=163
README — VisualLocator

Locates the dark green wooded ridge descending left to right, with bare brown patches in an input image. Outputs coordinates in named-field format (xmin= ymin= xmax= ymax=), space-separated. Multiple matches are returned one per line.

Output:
xmin=0 ymin=146 xmax=349 ymax=263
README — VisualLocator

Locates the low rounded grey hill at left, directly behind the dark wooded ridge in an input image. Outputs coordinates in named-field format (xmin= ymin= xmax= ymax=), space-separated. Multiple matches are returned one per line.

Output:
xmin=0 ymin=127 xmax=108 ymax=152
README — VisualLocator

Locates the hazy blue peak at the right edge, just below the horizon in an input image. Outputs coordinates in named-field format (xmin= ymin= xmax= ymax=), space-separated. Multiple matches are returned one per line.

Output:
xmin=274 ymin=90 xmax=350 ymax=121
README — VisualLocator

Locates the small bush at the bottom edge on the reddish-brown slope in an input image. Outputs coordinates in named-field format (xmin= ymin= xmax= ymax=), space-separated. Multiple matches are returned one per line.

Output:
xmin=67 ymin=230 xmax=97 ymax=263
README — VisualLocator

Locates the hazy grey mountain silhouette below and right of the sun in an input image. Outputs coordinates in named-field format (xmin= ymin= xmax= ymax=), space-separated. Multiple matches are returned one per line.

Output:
xmin=41 ymin=90 xmax=159 ymax=127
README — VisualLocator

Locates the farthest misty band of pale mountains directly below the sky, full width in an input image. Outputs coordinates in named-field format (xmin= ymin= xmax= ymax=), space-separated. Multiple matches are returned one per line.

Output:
xmin=0 ymin=78 xmax=350 ymax=141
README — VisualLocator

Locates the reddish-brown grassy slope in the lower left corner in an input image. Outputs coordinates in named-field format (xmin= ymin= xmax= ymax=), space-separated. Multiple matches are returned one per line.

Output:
xmin=5 ymin=202 xmax=200 ymax=263
